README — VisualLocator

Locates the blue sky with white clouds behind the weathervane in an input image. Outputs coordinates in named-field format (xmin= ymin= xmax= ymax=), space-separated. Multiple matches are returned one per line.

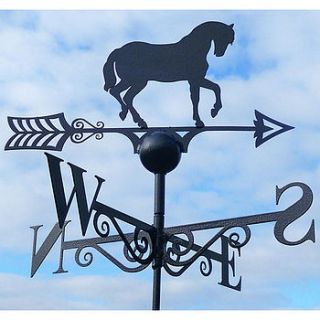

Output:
xmin=0 ymin=10 xmax=320 ymax=310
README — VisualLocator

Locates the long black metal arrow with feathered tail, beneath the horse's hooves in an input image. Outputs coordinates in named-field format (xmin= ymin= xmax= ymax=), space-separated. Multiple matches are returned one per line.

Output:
xmin=5 ymin=110 xmax=294 ymax=153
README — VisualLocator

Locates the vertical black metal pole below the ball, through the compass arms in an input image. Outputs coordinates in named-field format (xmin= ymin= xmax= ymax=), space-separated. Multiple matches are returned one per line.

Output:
xmin=152 ymin=173 xmax=165 ymax=310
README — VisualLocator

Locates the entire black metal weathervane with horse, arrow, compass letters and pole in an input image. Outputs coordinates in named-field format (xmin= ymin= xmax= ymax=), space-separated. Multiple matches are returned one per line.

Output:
xmin=5 ymin=21 xmax=315 ymax=310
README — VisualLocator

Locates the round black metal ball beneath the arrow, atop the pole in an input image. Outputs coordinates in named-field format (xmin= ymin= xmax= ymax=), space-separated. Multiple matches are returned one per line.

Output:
xmin=138 ymin=132 xmax=181 ymax=174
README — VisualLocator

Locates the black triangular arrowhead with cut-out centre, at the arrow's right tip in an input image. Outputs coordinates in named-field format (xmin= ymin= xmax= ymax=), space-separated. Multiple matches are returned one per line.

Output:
xmin=253 ymin=110 xmax=294 ymax=148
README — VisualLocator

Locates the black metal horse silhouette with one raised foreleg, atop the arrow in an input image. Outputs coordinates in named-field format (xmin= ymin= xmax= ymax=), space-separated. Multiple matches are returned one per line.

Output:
xmin=103 ymin=21 xmax=234 ymax=128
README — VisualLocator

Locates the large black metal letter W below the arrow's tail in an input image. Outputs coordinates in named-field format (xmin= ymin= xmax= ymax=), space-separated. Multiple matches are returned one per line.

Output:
xmin=45 ymin=152 xmax=105 ymax=236
